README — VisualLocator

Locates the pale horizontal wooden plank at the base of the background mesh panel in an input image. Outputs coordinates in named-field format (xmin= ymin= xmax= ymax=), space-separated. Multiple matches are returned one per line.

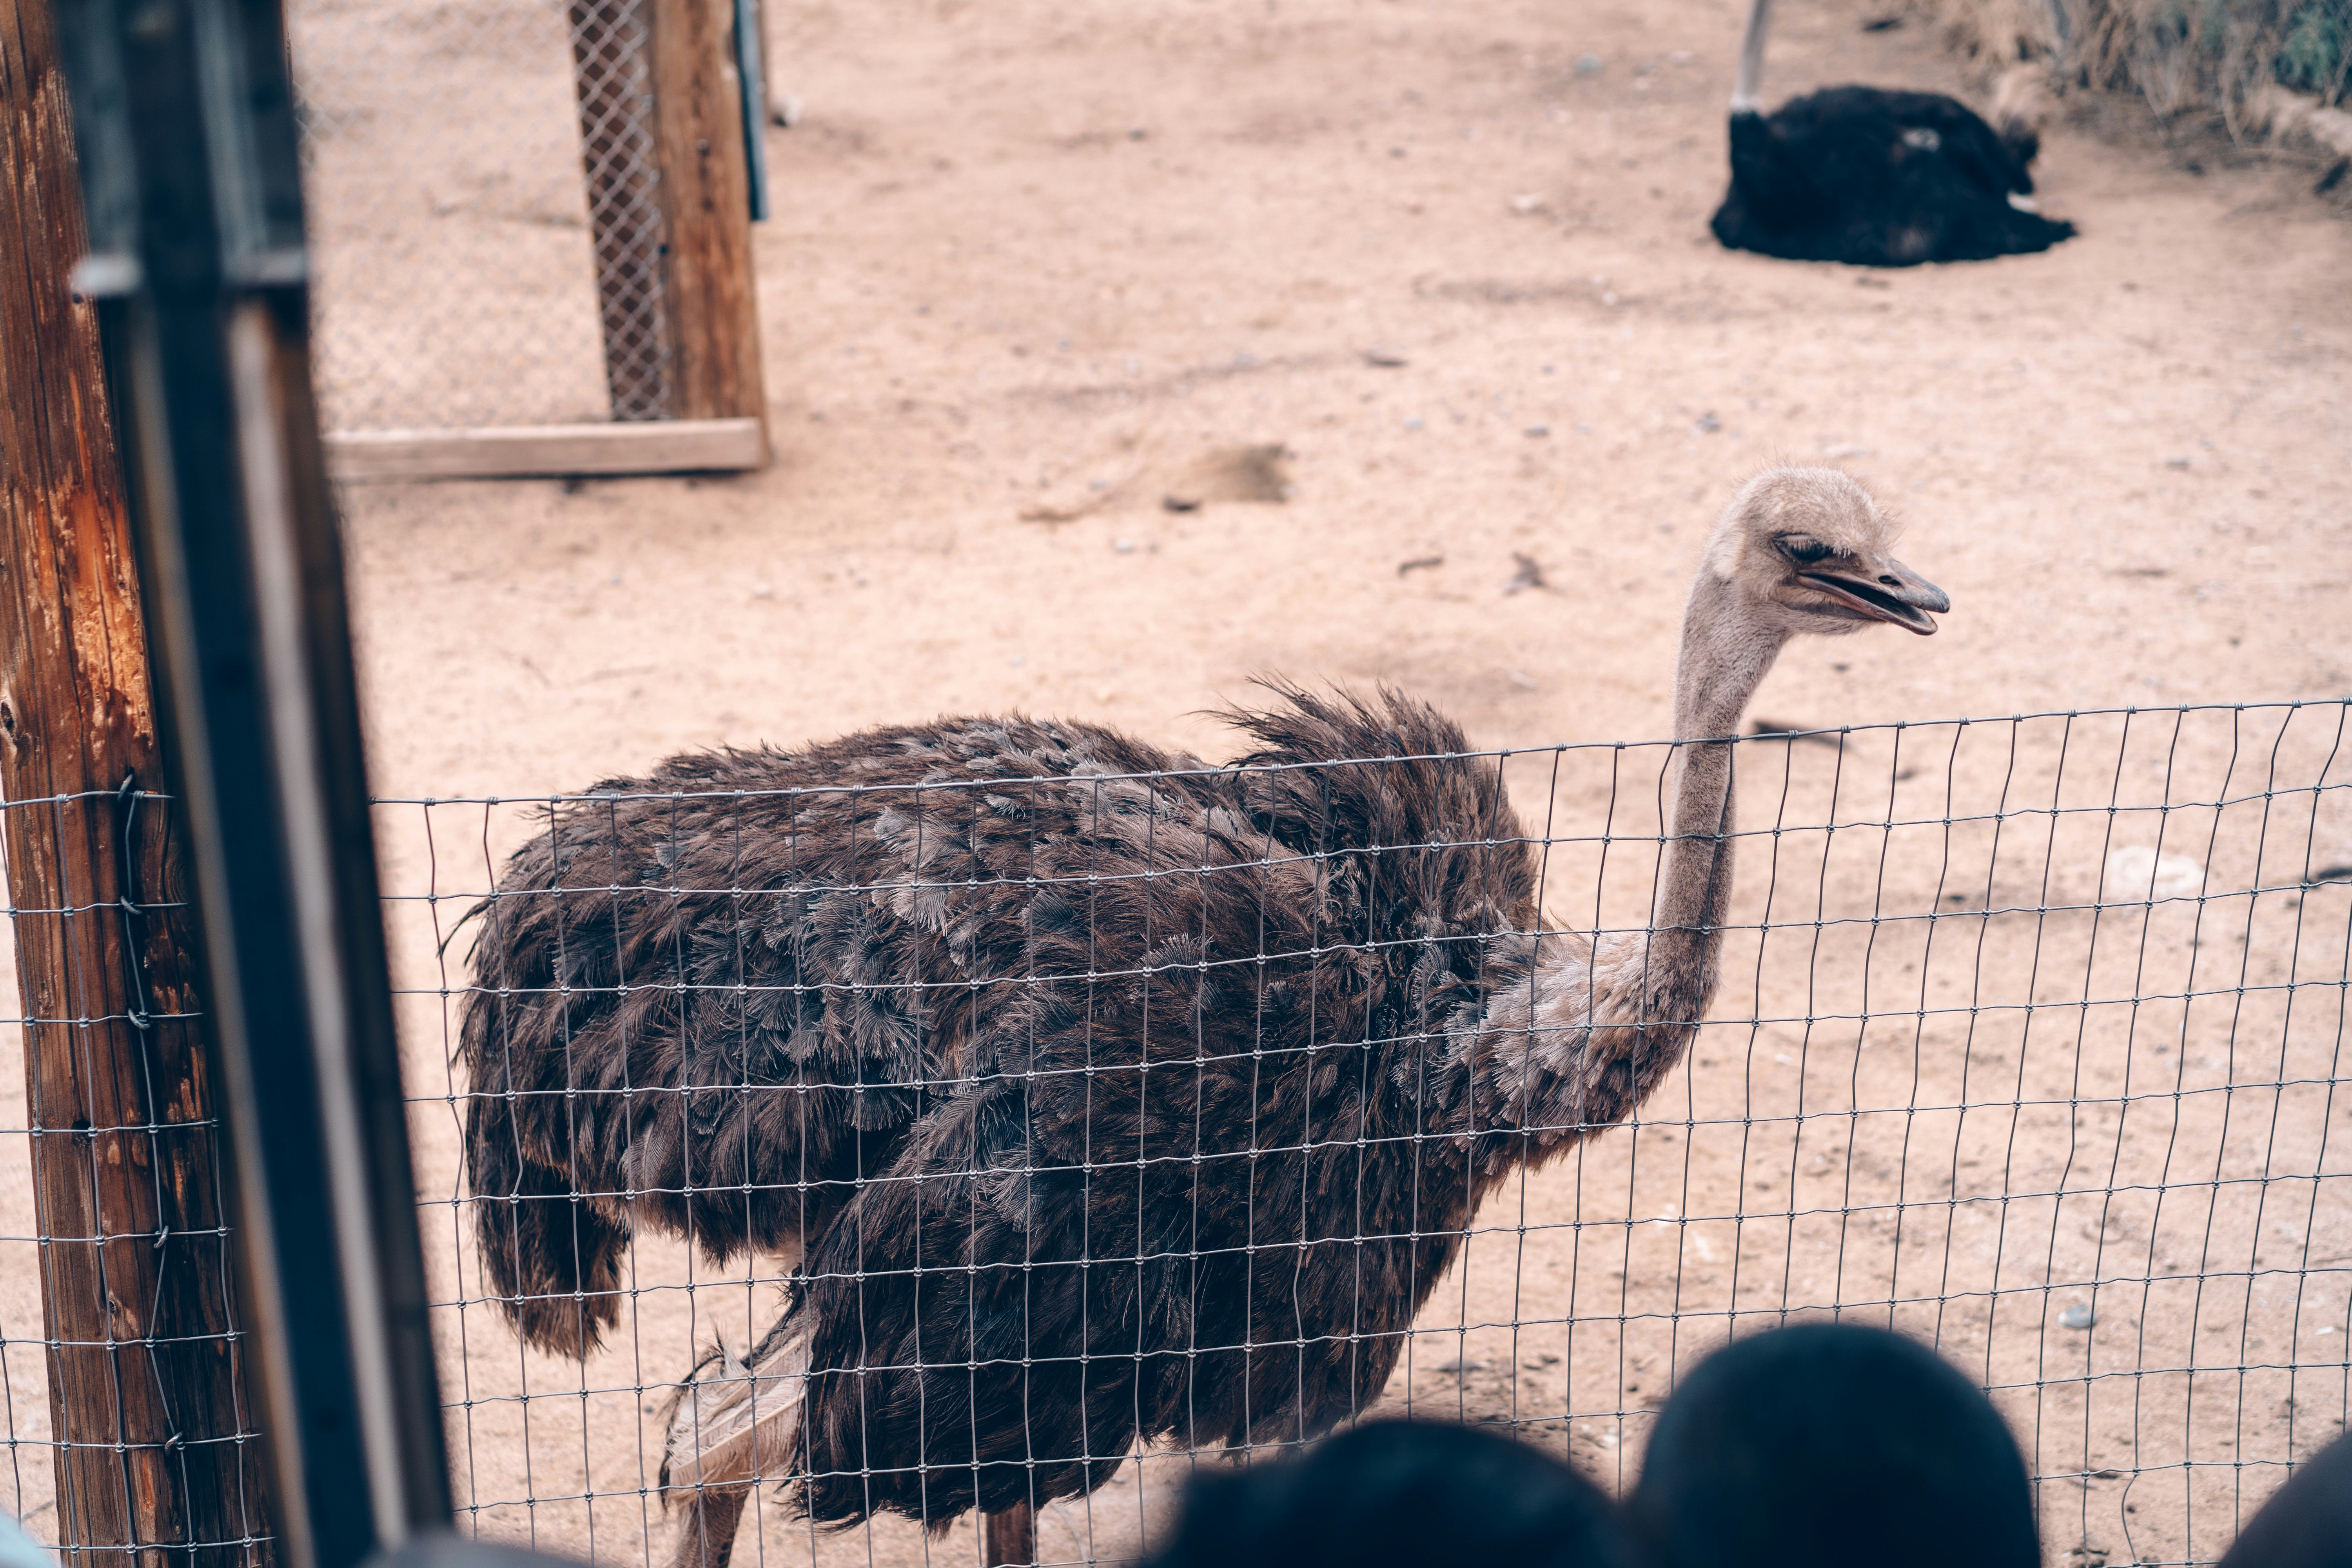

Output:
xmin=327 ymin=418 xmax=767 ymax=479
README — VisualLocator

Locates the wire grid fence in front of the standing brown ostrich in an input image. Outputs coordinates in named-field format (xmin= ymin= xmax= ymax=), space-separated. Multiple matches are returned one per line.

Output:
xmin=343 ymin=703 xmax=2352 ymax=1563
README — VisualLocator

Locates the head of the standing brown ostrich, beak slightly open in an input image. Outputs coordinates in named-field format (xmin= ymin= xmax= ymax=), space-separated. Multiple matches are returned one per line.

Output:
xmin=1700 ymin=468 xmax=1952 ymax=639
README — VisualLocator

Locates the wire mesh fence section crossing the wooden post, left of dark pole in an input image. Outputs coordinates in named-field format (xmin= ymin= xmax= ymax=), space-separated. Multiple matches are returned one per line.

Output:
xmin=0 ymin=783 xmax=270 ymax=1568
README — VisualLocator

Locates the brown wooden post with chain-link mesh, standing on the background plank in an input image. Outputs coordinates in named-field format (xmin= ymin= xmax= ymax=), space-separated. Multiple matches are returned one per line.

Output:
xmin=569 ymin=0 xmax=767 ymax=442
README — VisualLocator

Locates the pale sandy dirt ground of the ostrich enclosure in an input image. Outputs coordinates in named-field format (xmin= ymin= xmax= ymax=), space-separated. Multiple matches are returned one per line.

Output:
xmin=14 ymin=0 xmax=2352 ymax=1566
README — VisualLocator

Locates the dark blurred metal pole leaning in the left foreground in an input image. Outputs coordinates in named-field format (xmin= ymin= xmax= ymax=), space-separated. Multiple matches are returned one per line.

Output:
xmin=56 ymin=0 xmax=449 ymax=1568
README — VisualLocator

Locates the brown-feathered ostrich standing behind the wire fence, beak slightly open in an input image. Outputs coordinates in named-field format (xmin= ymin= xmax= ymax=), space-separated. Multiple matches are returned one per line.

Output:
xmin=459 ymin=468 xmax=1947 ymax=1568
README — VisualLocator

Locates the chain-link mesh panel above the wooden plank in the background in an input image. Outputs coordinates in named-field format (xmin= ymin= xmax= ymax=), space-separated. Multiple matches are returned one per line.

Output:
xmin=287 ymin=0 xmax=670 ymax=430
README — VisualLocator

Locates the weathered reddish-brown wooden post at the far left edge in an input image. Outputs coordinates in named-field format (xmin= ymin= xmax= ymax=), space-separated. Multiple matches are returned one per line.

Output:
xmin=0 ymin=0 xmax=270 ymax=1568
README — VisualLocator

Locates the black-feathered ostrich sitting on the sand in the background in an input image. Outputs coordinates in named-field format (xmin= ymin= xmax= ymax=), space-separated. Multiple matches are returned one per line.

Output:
xmin=1715 ymin=0 xmax=2074 ymax=266
